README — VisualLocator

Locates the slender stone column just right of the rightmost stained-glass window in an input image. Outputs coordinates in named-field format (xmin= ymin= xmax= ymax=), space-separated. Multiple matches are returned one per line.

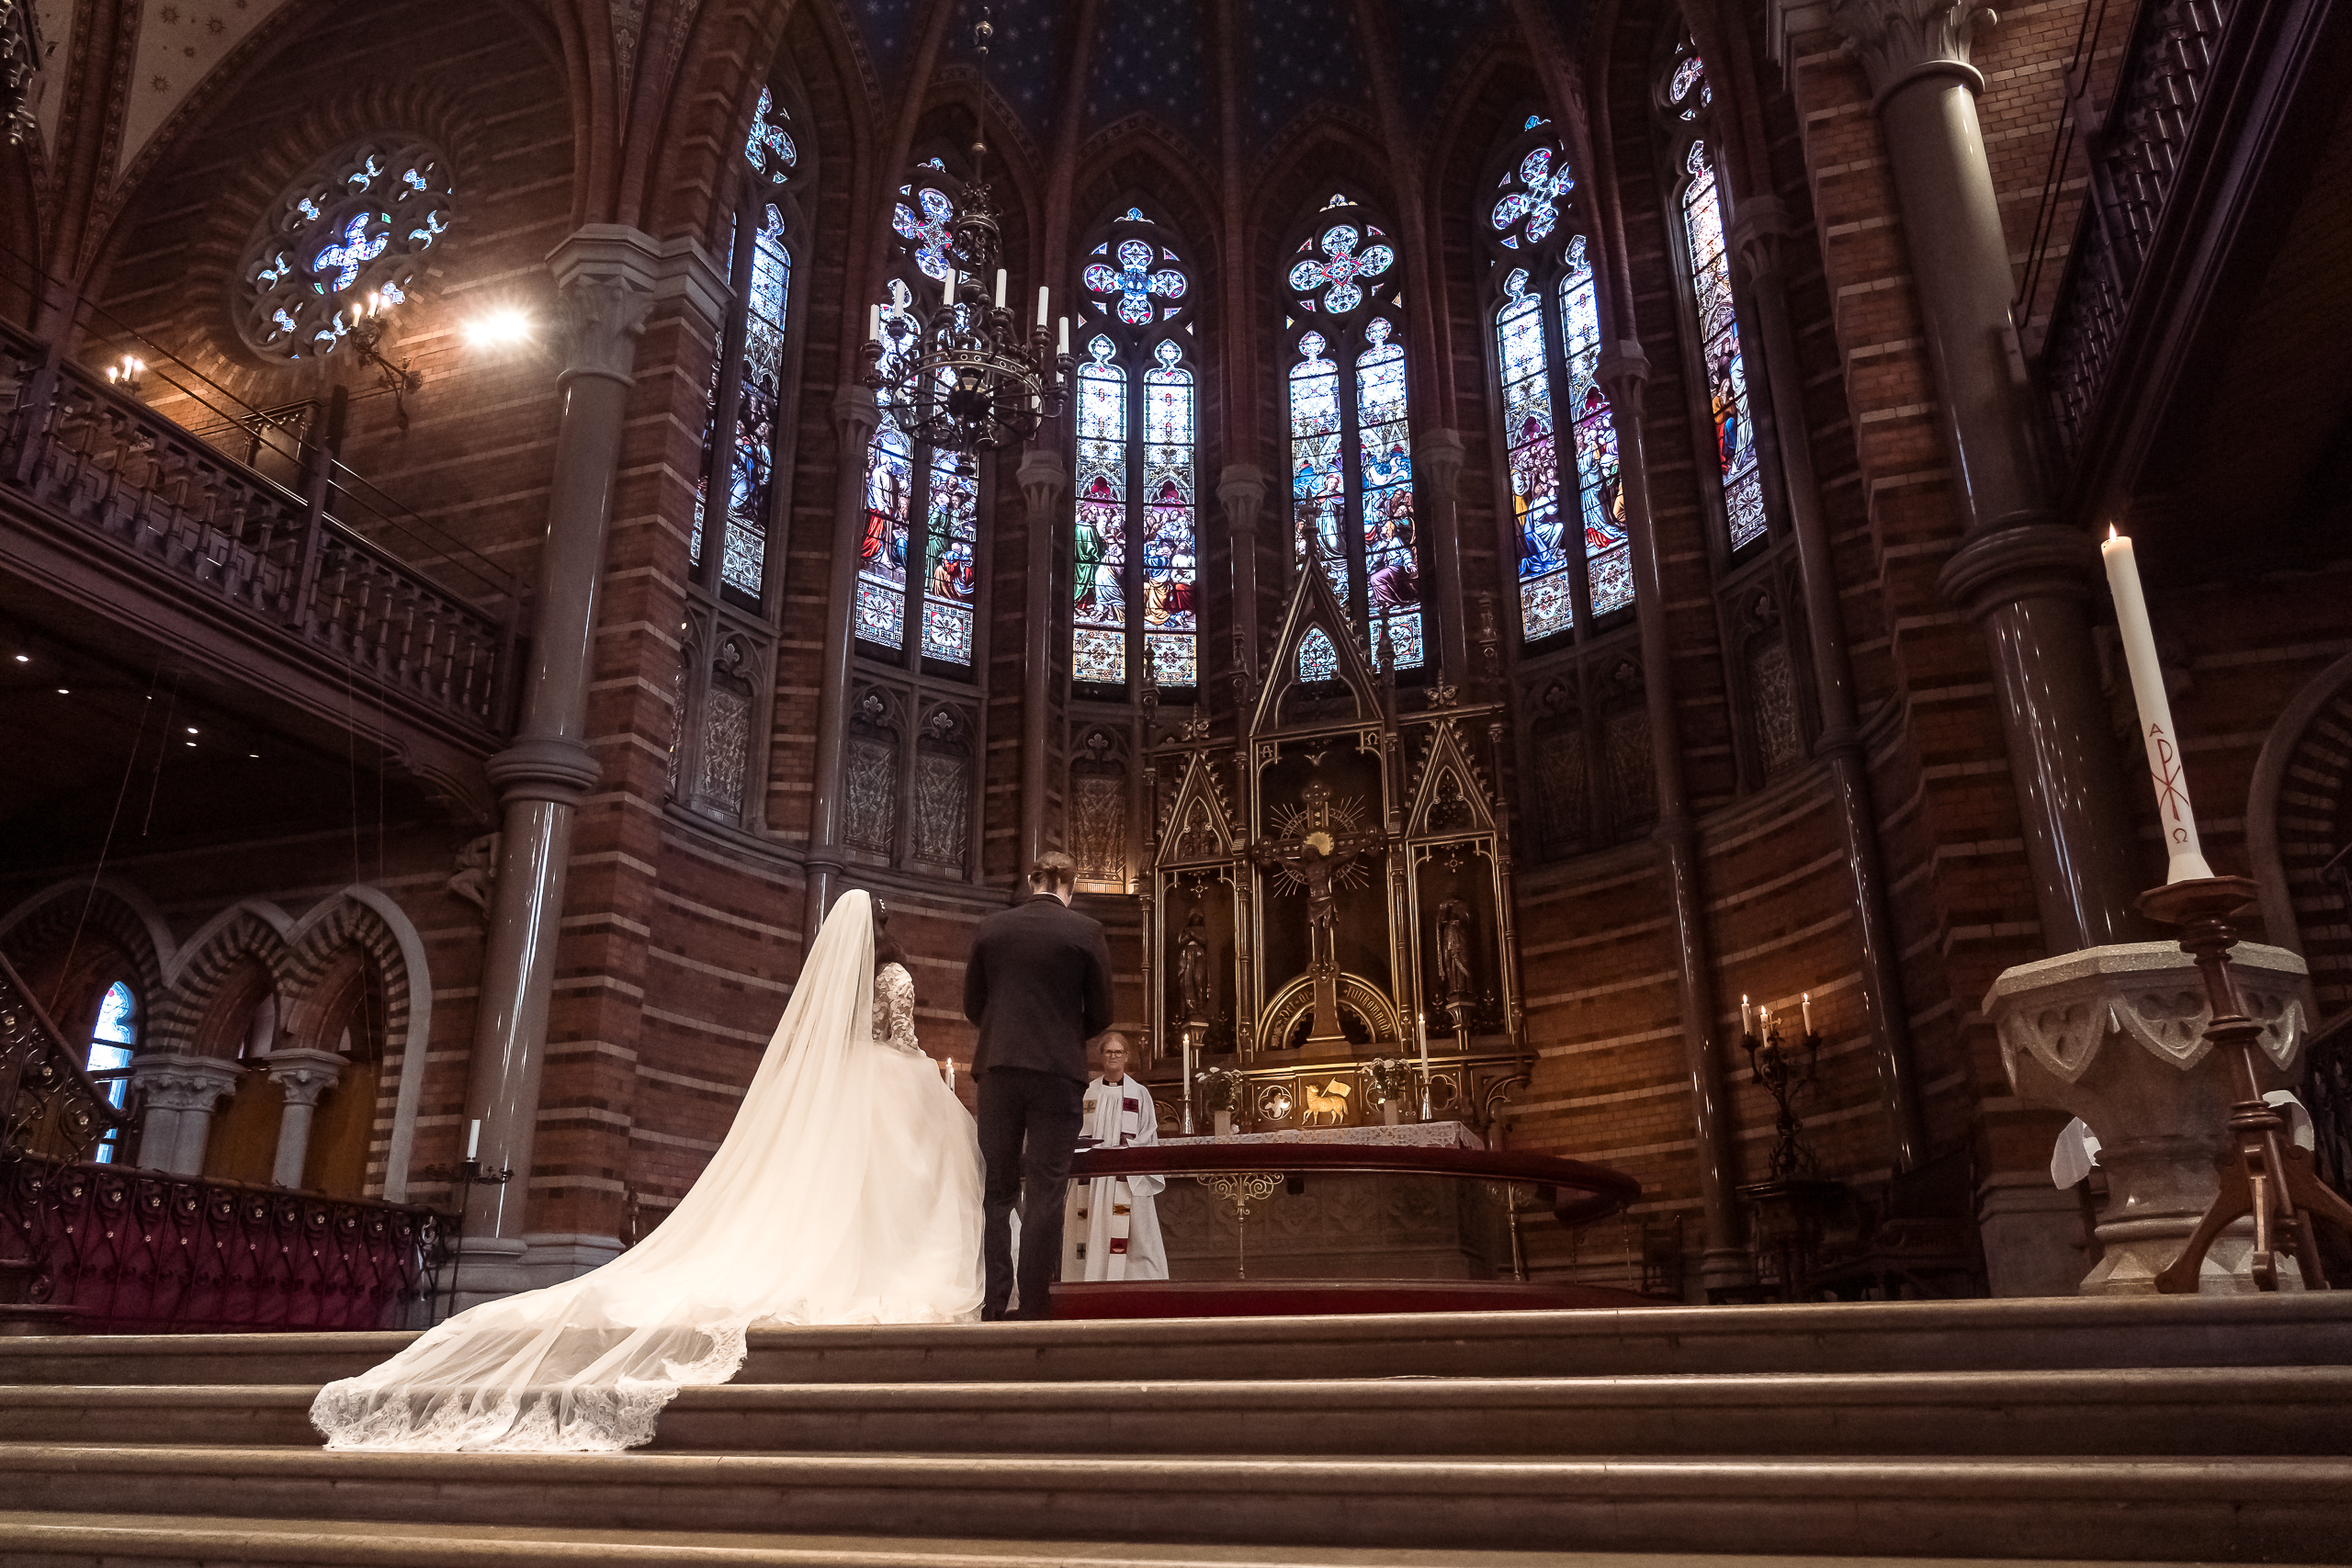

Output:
xmin=1731 ymin=195 xmax=1927 ymax=1170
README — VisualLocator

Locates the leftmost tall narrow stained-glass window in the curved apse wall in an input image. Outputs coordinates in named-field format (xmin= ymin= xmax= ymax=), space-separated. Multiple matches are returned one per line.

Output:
xmin=687 ymin=87 xmax=799 ymax=609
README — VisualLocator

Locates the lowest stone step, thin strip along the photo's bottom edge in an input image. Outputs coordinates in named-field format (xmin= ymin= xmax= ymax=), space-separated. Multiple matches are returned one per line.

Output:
xmin=0 ymin=1514 xmax=2248 ymax=1568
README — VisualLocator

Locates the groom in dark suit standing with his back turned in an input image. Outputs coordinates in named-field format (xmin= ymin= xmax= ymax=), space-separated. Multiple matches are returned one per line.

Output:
xmin=965 ymin=849 xmax=1110 ymax=1321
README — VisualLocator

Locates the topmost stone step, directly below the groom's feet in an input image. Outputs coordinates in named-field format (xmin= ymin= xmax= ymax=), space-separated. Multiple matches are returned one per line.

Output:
xmin=0 ymin=1291 xmax=2352 ymax=1384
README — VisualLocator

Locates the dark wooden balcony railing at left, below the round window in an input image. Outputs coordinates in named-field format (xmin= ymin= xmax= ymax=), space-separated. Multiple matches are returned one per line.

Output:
xmin=0 ymin=324 xmax=520 ymax=733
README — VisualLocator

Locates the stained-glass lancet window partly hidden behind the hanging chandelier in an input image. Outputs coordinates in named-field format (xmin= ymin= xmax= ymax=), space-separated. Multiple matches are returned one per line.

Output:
xmin=856 ymin=157 xmax=978 ymax=672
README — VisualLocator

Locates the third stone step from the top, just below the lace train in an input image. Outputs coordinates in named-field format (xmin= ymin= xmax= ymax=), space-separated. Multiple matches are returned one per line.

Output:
xmin=0 ymin=1443 xmax=2352 ymax=1563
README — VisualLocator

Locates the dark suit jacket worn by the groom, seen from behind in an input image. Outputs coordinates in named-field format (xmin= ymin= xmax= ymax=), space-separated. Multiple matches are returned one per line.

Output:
xmin=965 ymin=894 xmax=1110 ymax=1084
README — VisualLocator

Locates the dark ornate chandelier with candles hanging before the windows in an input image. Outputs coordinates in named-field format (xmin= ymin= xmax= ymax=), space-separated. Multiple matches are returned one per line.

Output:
xmin=861 ymin=7 xmax=1072 ymax=460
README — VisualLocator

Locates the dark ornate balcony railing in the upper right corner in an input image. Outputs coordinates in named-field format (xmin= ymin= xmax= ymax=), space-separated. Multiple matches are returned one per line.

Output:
xmin=2041 ymin=0 xmax=2244 ymax=461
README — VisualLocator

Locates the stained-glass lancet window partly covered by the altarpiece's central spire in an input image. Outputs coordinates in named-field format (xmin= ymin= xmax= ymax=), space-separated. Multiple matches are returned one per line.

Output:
xmin=1282 ymin=195 xmax=1423 ymax=680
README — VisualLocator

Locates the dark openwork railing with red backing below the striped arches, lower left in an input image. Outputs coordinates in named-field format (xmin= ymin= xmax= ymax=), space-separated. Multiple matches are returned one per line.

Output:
xmin=0 ymin=957 xmax=445 ymax=1333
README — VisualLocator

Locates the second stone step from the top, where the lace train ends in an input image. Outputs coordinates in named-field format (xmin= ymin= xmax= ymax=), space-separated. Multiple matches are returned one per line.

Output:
xmin=0 ymin=1366 xmax=2352 ymax=1458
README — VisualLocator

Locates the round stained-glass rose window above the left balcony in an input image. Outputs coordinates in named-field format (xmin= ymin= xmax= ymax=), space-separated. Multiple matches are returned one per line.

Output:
xmin=238 ymin=136 xmax=452 ymax=360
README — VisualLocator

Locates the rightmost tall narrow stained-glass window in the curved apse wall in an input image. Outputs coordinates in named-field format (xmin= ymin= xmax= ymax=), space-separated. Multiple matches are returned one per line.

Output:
xmin=1658 ymin=33 xmax=1767 ymax=550
